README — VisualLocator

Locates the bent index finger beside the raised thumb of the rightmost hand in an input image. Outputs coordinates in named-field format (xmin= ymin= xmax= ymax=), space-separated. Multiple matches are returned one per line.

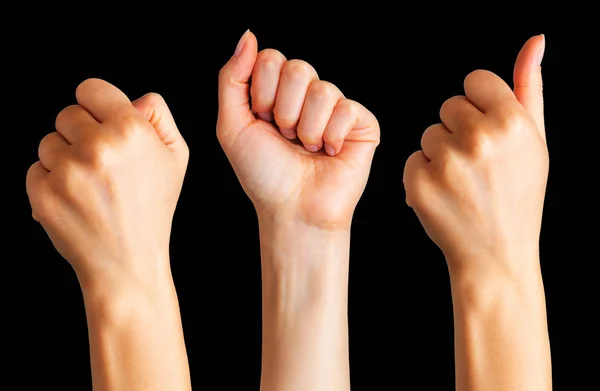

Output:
xmin=464 ymin=70 xmax=517 ymax=113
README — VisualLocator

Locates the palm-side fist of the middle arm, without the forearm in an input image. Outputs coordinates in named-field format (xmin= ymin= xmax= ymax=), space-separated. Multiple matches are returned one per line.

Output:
xmin=217 ymin=32 xmax=379 ymax=233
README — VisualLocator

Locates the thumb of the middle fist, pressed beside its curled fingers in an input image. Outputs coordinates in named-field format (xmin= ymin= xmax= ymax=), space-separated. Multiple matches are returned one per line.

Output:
xmin=217 ymin=30 xmax=258 ymax=142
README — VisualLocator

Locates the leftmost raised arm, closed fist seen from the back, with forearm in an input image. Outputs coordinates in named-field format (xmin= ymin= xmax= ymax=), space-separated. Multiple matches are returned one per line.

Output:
xmin=27 ymin=79 xmax=191 ymax=391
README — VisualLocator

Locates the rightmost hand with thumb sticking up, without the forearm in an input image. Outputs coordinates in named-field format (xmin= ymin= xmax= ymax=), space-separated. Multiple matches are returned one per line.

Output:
xmin=404 ymin=36 xmax=548 ymax=278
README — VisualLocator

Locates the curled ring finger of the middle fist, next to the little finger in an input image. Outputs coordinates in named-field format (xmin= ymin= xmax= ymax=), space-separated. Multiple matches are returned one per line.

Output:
xmin=297 ymin=80 xmax=345 ymax=152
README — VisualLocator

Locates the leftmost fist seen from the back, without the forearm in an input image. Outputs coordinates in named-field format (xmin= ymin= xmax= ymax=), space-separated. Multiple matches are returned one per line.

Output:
xmin=27 ymin=79 xmax=188 ymax=288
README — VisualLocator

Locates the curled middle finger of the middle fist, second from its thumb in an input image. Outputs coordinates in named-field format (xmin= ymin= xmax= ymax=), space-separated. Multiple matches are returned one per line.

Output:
xmin=273 ymin=60 xmax=319 ymax=139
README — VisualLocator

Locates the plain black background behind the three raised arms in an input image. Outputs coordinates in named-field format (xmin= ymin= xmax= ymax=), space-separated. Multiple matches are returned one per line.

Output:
xmin=5 ymin=9 xmax=598 ymax=391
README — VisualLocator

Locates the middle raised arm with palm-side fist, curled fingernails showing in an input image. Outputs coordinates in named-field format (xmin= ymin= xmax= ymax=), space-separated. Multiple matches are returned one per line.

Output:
xmin=217 ymin=31 xmax=379 ymax=391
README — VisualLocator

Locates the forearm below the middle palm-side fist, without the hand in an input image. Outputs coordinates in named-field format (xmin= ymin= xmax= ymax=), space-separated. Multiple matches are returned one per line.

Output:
xmin=260 ymin=220 xmax=350 ymax=391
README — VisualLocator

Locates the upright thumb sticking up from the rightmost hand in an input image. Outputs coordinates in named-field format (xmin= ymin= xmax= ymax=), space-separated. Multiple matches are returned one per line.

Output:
xmin=513 ymin=34 xmax=546 ymax=141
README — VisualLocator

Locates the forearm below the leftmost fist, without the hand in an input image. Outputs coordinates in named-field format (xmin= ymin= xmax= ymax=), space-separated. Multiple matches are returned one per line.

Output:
xmin=84 ymin=266 xmax=191 ymax=391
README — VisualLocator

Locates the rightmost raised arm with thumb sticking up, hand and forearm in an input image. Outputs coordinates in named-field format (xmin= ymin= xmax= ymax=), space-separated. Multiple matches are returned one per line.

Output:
xmin=404 ymin=36 xmax=552 ymax=391
